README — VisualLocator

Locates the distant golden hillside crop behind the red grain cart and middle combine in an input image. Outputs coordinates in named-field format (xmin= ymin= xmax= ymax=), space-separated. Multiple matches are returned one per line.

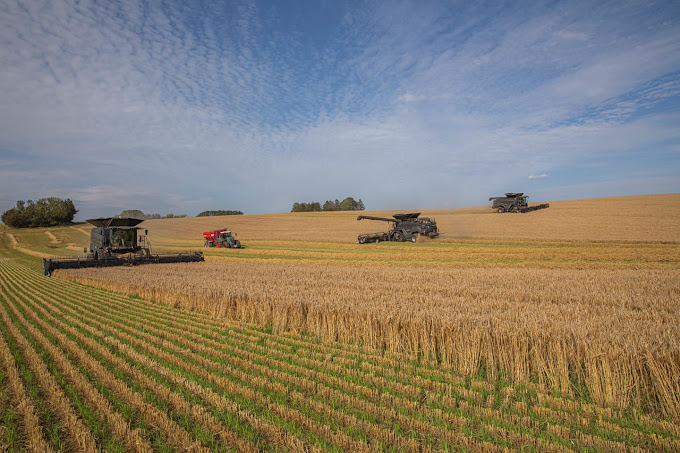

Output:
xmin=143 ymin=194 xmax=680 ymax=246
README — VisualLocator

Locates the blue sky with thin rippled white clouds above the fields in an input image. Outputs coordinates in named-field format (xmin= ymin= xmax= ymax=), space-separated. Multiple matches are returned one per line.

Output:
xmin=0 ymin=0 xmax=680 ymax=220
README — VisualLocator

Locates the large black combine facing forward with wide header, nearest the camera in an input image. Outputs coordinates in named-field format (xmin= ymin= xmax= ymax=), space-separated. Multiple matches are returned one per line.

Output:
xmin=43 ymin=217 xmax=204 ymax=277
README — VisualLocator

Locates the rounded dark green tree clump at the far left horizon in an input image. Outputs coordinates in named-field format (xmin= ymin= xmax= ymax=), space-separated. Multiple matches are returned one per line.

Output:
xmin=2 ymin=197 xmax=78 ymax=228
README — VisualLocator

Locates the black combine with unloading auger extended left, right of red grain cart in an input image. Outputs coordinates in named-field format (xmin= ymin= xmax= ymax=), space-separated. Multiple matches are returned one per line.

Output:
xmin=357 ymin=212 xmax=439 ymax=244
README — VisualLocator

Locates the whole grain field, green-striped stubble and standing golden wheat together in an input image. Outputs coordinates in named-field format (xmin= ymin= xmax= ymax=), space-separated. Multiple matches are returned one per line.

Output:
xmin=0 ymin=195 xmax=680 ymax=451
